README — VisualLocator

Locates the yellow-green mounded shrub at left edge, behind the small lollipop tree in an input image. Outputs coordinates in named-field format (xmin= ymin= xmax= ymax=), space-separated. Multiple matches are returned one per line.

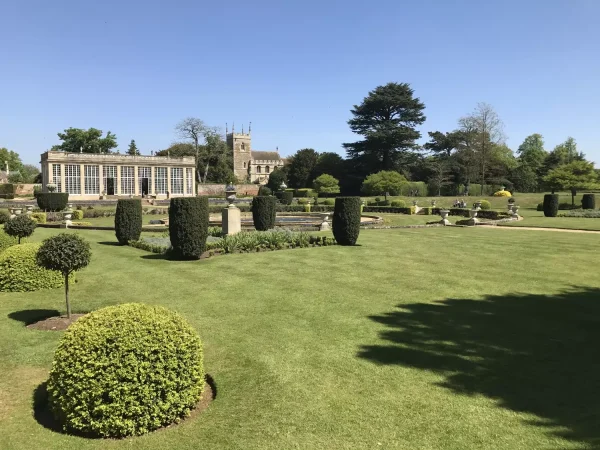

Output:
xmin=0 ymin=243 xmax=64 ymax=292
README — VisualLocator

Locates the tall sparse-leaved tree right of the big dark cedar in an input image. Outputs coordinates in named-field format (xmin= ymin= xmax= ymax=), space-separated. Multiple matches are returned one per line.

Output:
xmin=459 ymin=103 xmax=505 ymax=187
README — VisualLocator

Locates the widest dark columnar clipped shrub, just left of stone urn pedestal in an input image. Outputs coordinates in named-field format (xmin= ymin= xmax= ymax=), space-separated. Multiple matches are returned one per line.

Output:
xmin=169 ymin=196 xmax=208 ymax=259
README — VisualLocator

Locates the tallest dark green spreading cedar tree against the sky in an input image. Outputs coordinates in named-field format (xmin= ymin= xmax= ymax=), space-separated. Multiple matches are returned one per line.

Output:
xmin=343 ymin=83 xmax=425 ymax=173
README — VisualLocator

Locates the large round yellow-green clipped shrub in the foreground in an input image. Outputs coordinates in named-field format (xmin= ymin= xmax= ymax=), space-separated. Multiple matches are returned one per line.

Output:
xmin=47 ymin=303 xmax=204 ymax=437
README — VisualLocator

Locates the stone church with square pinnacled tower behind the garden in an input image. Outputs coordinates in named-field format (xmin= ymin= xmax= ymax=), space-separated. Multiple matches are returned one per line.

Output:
xmin=226 ymin=124 xmax=285 ymax=184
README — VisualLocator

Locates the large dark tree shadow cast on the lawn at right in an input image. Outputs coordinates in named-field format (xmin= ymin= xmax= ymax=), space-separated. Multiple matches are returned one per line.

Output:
xmin=358 ymin=288 xmax=600 ymax=445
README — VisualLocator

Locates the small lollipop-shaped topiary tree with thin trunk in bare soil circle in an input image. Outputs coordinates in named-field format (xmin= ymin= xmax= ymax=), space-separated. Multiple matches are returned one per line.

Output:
xmin=37 ymin=233 xmax=92 ymax=319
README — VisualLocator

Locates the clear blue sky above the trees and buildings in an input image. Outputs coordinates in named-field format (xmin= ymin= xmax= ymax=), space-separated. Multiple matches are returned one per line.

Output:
xmin=0 ymin=0 xmax=600 ymax=165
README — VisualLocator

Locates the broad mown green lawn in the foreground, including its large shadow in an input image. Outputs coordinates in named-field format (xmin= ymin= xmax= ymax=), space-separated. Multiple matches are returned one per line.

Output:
xmin=0 ymin=230 xmax=600 ymax=450
